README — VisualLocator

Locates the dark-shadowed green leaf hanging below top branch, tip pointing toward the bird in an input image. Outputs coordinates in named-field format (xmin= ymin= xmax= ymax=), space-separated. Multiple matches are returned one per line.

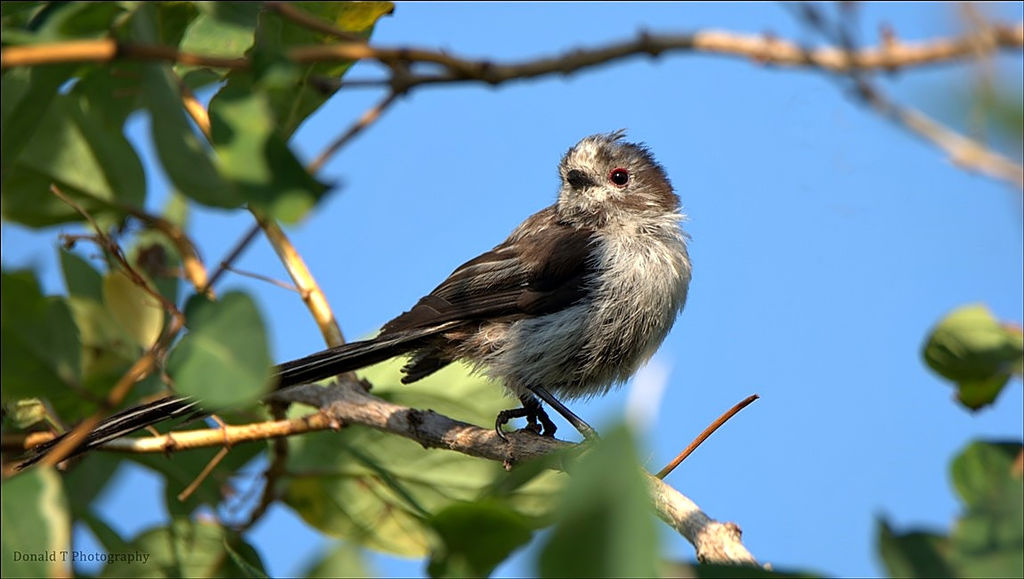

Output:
xmin=210 ymin=75 xmax=327 ymax=222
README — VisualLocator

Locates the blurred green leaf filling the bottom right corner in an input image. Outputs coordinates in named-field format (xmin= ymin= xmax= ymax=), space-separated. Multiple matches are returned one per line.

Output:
xmin=951 ymin=442 xmax=1024 ymax=577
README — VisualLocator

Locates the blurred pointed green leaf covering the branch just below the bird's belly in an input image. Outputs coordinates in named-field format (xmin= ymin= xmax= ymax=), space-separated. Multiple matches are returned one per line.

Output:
xmin=538 ymin=426 xmax=658 ymax=577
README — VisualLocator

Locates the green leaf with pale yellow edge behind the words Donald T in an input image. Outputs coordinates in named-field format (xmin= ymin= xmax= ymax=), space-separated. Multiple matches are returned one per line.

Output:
xmin=0 ymin=467 xmax=71 ymax=577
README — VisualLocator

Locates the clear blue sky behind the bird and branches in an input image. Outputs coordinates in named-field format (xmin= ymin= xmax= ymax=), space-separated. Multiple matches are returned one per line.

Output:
xmin=2 ymin=3 xmax=1024 ymax=576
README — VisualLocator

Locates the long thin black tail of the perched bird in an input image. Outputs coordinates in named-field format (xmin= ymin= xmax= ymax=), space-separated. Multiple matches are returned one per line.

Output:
xmin=17 ymin=325 xmax=447 ymax=469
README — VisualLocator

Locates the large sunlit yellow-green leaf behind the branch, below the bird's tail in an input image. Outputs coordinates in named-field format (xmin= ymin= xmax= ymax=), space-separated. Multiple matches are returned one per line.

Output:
xmin=284 ymin=360 xmax=564 ymax=556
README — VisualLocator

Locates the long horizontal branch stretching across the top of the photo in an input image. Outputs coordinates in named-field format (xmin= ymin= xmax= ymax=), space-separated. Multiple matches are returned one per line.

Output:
xmin=0 ymin=23 xmax=1024 ymax=77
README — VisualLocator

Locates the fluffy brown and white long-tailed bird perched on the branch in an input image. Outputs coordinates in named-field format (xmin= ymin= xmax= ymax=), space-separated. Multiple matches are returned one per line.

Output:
xmin=20 ymin=130 xmax=691 ymax=467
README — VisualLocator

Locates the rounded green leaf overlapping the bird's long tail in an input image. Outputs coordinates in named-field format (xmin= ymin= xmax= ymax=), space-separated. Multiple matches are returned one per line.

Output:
xmin=167 ymin=292 xmax=270 ymax=409
